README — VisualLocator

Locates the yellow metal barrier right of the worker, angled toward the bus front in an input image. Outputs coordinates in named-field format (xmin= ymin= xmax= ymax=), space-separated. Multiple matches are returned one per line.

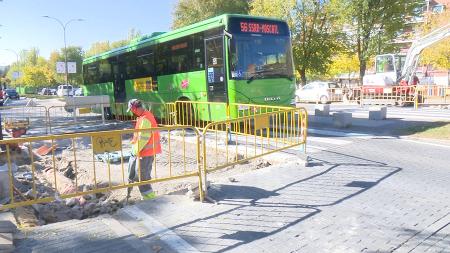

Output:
xmin=202 ymin=108 xmax=308 ymax=189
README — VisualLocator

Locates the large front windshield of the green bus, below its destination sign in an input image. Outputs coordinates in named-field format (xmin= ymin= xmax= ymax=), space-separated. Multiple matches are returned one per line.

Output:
xmin=230 ymin=34 xmax=293 ymax=80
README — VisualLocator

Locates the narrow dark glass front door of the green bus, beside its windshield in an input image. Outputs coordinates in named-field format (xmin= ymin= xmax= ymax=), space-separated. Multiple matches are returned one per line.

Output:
xmin=205 ymin=36 xmax=227 ymax=102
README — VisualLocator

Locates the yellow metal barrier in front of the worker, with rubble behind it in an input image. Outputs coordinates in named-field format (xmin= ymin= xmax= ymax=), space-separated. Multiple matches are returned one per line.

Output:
xmin=0 ymin=126 xmax=203 ymax=210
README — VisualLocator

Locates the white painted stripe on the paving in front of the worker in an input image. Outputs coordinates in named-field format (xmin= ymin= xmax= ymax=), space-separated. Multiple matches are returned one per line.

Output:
xmin=124 ymin=206 xmax=200 ymax=252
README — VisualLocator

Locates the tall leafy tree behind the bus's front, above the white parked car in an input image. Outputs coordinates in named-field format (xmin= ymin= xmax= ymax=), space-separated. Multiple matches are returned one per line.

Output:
xmin=250 ymin=0 xmax=340 ymax=84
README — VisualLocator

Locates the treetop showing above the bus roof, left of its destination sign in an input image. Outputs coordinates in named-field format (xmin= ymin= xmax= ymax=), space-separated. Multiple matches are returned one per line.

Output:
xmin=172 ymin=0 xmax=249 ymax=29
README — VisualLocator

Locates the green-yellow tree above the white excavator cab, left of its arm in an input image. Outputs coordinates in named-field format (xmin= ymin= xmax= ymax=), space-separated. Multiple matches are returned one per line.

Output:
xmin=338 ymin=0 xmax=423 ymax=82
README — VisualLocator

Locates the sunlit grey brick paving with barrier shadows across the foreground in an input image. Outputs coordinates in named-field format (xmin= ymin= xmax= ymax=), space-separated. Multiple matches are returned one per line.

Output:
xmin=14 ymin=131 xmax=450 ymax=252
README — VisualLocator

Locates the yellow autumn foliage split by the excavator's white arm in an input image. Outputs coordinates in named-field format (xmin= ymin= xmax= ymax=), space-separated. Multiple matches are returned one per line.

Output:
xmin=420 ymin=9 xmax=450 ymax=69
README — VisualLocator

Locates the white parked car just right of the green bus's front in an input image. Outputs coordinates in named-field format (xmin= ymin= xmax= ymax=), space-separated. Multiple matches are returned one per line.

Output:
xmin=295 ymin=81 xmax=343 ymax=104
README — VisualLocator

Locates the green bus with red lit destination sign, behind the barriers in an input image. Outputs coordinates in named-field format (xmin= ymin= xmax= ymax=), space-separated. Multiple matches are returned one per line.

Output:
xmin=83 ymin=14 xmax=295 ymax=120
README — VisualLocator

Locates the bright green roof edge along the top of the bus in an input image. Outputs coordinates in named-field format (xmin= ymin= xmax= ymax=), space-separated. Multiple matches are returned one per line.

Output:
xmin=83 ymin=14 xmax=282 ymax=64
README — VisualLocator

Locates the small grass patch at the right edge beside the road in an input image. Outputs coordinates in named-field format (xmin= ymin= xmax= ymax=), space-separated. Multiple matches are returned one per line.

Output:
xmin=403 ymin=121 xmax=450 ymax=140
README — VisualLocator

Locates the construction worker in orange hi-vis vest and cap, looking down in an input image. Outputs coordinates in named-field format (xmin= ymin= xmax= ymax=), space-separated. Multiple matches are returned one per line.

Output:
xmin=127 ymin=99 xmax=161 ymax=199
